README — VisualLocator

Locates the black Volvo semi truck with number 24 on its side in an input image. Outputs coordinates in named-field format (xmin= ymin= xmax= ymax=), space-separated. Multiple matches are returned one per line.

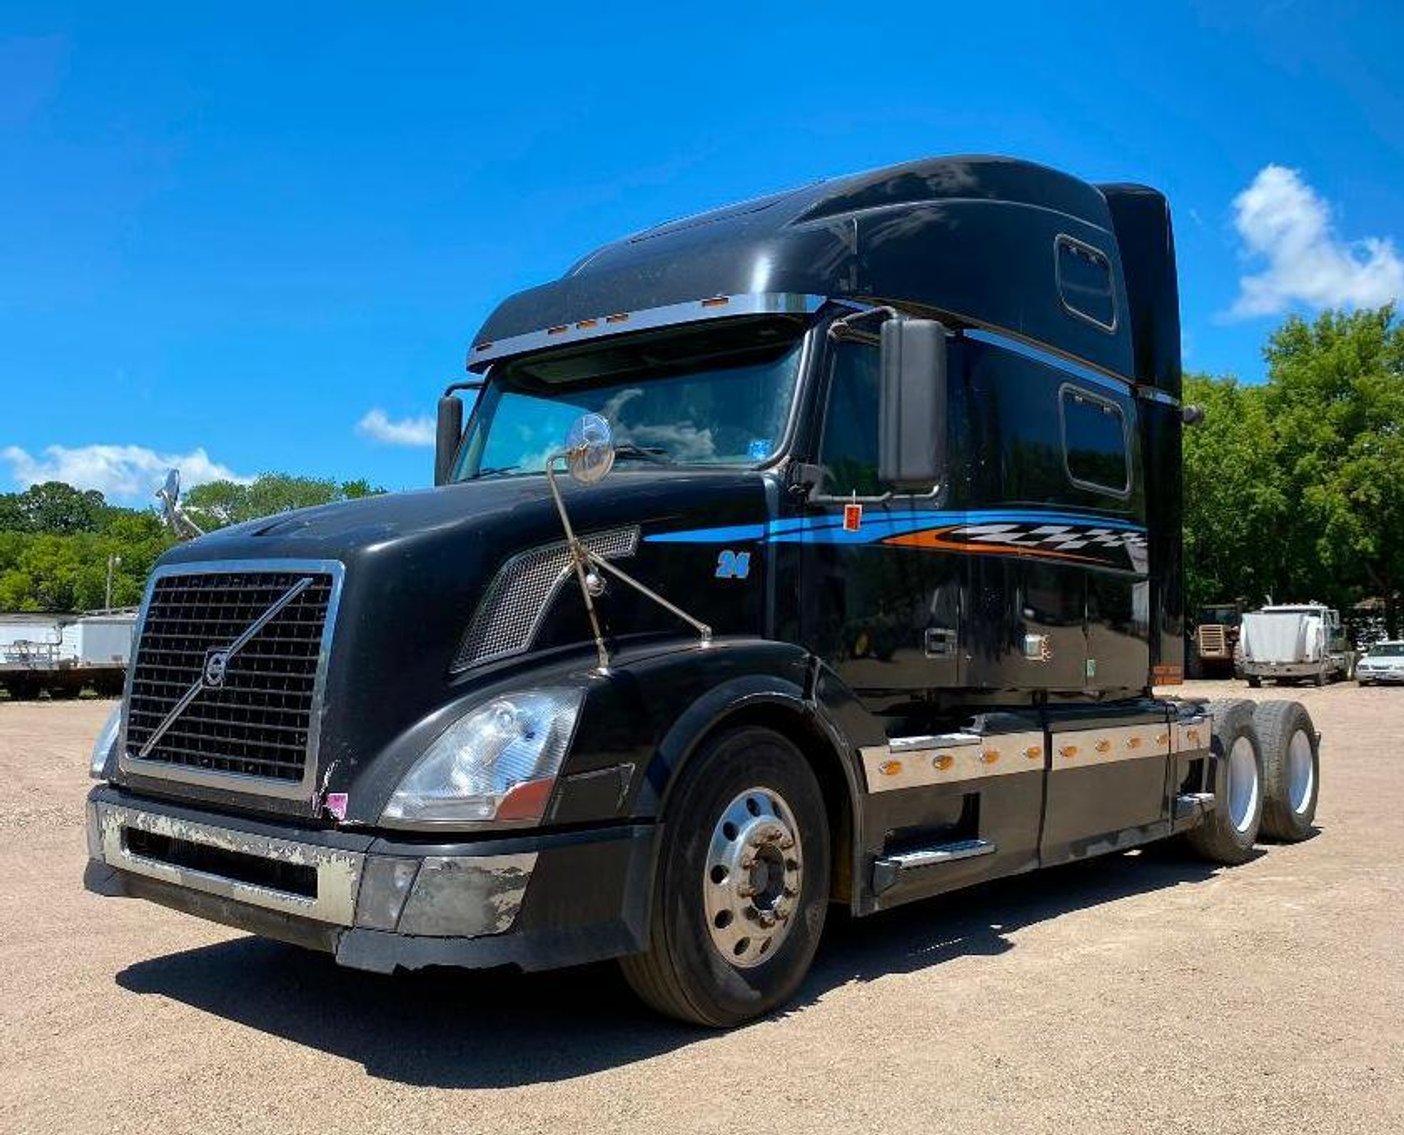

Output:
xmin=86 ymin=157 xmax=1320 ymax=1025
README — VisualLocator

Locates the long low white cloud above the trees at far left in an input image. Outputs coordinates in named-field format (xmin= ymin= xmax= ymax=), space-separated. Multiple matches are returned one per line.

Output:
xmin=0 ymin=445 xmax=253 ymax=503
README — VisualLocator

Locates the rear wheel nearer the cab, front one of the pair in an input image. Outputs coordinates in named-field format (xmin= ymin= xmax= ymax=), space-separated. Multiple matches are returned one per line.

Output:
xmin=1186 ymin=700 xmax=1264 ymax=865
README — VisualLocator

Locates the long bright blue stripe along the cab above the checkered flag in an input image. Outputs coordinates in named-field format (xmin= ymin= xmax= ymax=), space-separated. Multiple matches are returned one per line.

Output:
xmin=644 ymin=509 xmax=1146 ymax=544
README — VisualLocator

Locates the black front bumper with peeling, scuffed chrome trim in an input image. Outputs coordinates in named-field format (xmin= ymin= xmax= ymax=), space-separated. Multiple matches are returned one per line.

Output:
xmin=84 ymin=785 xmax=656 ymax=972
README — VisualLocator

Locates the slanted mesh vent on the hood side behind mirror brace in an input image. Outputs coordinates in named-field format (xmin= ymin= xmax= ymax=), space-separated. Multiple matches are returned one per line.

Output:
xmin=453 ymin=528 xmax=639 ymax=670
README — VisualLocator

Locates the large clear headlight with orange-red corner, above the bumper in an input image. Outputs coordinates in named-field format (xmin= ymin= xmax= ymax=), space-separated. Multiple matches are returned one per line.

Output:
xmin=380 ymin=688 xmax=584 ymax=826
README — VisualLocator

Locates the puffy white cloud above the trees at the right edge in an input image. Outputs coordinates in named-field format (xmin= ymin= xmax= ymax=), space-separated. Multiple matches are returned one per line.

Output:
xmin=1230 ymin=166 xmax=1404 ymax=317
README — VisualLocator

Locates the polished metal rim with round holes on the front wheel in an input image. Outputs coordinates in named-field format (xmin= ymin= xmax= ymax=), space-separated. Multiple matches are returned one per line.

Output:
xmin=702 ymin=788 xmax=804 ymax=969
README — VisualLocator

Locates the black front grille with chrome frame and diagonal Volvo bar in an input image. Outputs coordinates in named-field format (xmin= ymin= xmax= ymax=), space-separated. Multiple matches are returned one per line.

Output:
xmin=125 ymin=563 xmax=340 ymax=792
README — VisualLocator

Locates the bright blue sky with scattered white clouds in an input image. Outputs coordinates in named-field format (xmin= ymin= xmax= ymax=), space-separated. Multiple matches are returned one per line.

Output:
xmin=0 ymin=3 xmax=1404 ymax=503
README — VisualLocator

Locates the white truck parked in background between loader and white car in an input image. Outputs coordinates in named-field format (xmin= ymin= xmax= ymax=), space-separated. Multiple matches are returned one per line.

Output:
xmin=1237 ymin=603 xmax=1355 ymax=688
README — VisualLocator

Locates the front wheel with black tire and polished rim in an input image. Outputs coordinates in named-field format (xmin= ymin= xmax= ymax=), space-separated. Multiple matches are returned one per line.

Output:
xmin=619 ymin=726 xmax=830 ymax=1028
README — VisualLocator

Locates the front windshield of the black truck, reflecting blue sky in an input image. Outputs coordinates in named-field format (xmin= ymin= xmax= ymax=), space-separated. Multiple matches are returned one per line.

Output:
xmin=453 ymin=319 xmax=803 ymax=480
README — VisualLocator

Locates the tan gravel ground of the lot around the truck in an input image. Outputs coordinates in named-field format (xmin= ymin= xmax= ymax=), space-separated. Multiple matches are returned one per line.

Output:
xmin=0 ymin=683 xmax=1404 ymax=1135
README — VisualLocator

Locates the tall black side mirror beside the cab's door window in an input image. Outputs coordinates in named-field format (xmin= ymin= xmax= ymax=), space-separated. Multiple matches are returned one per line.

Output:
xmin=878 ymin=319 xmax=946 ymax=492
